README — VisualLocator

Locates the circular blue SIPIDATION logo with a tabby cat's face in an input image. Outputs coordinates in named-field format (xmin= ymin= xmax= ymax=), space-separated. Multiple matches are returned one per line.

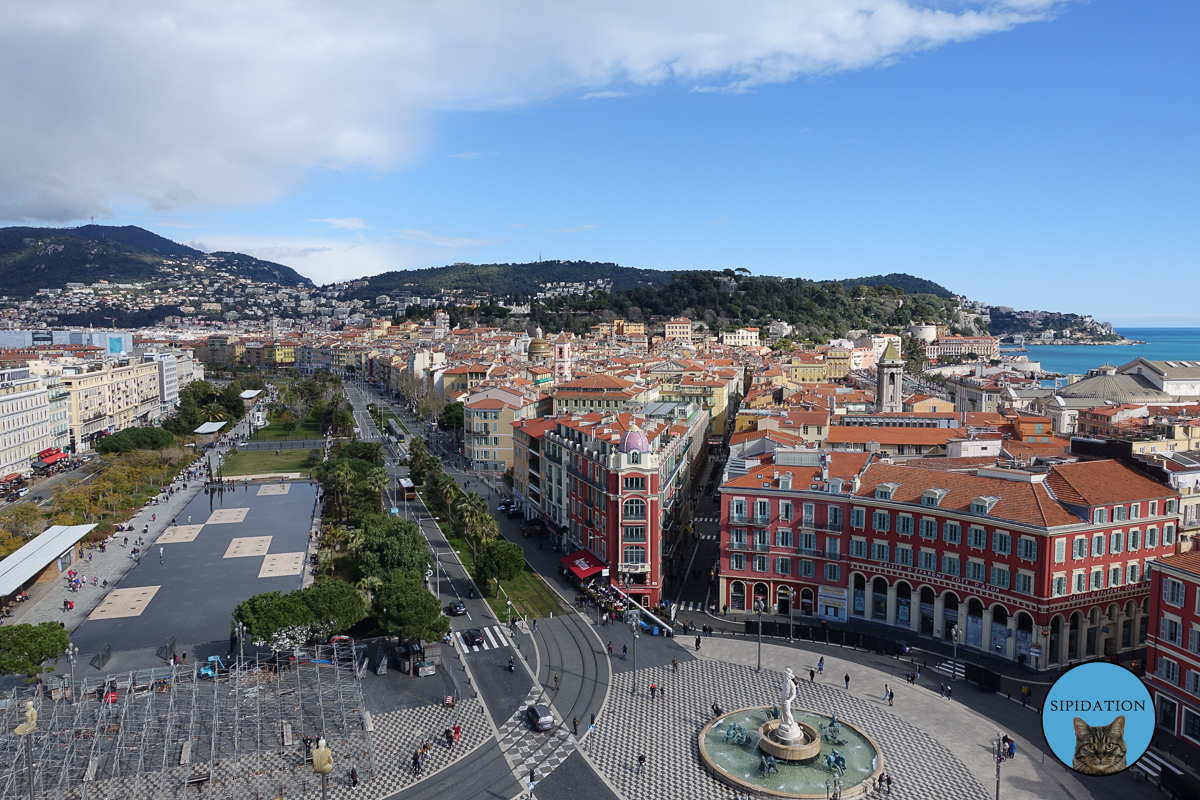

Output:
xmin=1042 ymin=661 xmax=1154 ymax=776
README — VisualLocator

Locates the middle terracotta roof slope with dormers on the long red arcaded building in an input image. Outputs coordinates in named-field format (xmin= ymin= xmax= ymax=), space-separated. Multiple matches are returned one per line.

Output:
xmin=854 ymin=464 xmax=1081 ymax=528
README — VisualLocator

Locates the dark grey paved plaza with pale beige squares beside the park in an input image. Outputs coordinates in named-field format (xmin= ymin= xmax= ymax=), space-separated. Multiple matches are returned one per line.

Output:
xmin=71 ymin=481 xmax=317 ymax=662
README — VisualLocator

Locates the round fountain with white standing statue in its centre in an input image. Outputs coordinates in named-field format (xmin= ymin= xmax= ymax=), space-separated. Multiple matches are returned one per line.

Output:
xmin=700 ymin=669 xmax=883 ymax=799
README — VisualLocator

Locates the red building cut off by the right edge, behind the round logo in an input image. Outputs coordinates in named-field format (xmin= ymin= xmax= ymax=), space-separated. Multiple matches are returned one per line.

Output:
xmin=1145 ymin=552 xmax=1200 ymax=758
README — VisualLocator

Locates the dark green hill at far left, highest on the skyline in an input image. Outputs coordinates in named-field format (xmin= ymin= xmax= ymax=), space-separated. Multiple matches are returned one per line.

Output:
xmin=0 ymin=225 xmax=312 ymax=297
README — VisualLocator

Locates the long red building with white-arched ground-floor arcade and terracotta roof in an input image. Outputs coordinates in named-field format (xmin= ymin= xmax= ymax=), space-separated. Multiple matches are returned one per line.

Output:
xmin=720 ymin=451 xmax=1180 ymax=666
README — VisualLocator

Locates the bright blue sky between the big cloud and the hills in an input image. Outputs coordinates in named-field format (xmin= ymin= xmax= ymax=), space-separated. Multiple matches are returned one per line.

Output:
xmin=0 ymin=0 xmax=1200 ymax=326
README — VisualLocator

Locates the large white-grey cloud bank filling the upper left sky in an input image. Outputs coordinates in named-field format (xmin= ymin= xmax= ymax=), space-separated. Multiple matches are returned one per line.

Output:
xmin=0 ymin=0 xmax=1058 ymax=222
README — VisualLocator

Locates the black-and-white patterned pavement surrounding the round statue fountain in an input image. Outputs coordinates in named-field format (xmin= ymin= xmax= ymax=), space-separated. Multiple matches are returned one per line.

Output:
xmin=586 ymin=660 xmax=989 ymax=800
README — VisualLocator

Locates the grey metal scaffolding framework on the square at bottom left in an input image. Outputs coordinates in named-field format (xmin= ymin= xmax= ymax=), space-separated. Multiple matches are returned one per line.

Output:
xmin=0 ymin=642 xmax=376 ymax=800
